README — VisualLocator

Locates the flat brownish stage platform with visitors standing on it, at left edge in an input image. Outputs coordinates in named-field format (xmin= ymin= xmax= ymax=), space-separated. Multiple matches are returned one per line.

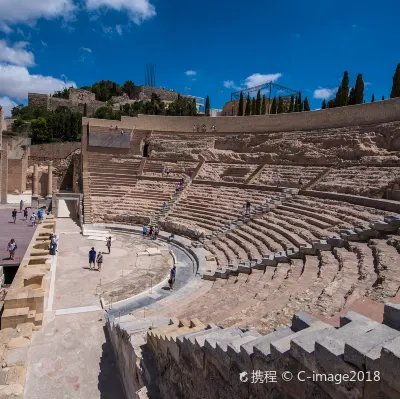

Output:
xmin=0 ymin=204 xmax=36 ymax=266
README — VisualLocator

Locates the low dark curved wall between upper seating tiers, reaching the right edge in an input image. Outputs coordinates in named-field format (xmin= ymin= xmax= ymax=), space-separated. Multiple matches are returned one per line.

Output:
xmin=300 ymin=190 xmax=400 ymax=213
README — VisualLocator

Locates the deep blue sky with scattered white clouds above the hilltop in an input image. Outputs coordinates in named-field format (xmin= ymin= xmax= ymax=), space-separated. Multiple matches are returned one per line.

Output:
xmin=0 ymin=0 xmax=400 ymax=113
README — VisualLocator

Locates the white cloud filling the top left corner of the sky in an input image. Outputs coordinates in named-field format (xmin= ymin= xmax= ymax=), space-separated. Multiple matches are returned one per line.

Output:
xmin=0 ymin=0 xmax=76 ymax=32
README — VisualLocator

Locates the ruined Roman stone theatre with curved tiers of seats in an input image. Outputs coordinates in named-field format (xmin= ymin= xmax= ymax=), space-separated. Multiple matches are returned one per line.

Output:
xmin=0 ymin=98 xmax=400 ymax=399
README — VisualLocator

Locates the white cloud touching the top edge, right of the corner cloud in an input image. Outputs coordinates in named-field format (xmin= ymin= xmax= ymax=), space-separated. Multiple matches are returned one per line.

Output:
xmin=86 ymin=0 xmax=156 ymax=25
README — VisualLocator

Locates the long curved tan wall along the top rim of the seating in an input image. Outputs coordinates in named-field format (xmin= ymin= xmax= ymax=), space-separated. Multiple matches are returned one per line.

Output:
xmin=82 ymin=98 xmax=400 ymax=133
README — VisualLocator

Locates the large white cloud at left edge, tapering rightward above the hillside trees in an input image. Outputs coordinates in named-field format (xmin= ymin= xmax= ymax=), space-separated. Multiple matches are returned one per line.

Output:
xmin=0 ymin=64 xmax=76 ymax=99
